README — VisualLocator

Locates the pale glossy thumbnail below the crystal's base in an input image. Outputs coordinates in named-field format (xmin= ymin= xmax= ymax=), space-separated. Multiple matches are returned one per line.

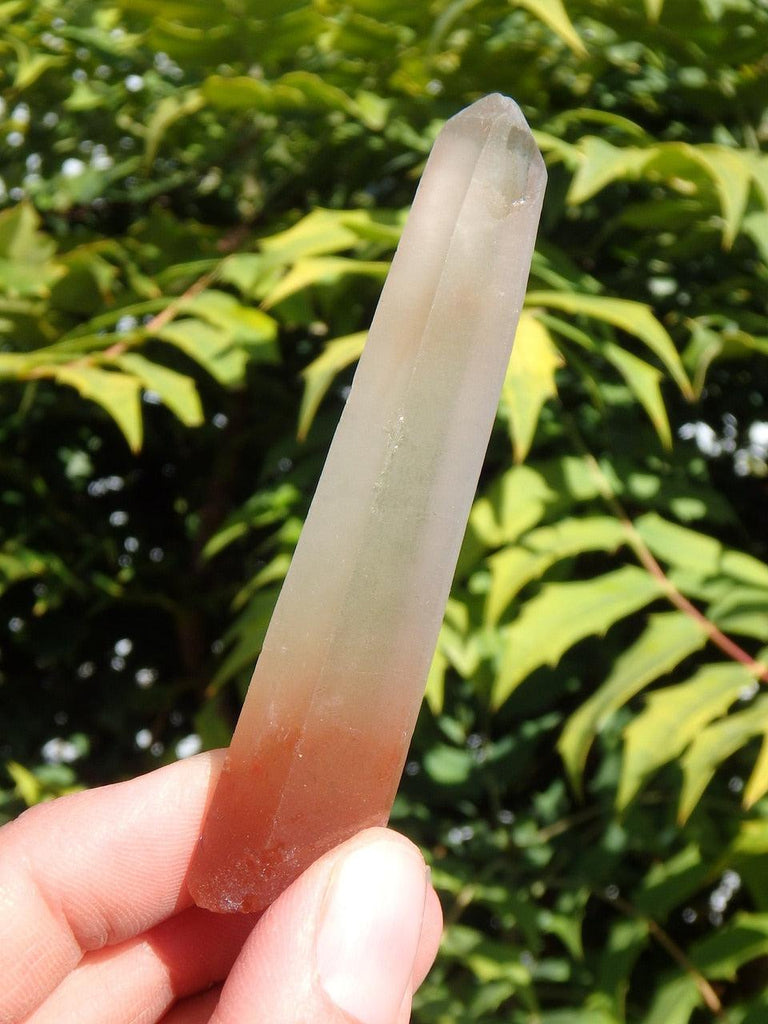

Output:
xmin=317 ymin=839 xmax=426 ymax=1024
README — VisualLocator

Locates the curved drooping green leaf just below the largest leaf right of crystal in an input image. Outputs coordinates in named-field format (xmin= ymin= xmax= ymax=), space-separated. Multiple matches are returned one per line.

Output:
xmin=557 ymin=610 xmax=707 ymax=793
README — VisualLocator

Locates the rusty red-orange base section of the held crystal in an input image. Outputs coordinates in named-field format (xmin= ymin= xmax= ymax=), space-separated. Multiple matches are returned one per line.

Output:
xmin=186 ymin=722 xmax=409 ymax=912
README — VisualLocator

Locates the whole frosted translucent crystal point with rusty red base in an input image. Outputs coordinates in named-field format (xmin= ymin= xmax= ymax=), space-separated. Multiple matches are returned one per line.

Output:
xmin=187 ymin=95 xmax=546 ymax=911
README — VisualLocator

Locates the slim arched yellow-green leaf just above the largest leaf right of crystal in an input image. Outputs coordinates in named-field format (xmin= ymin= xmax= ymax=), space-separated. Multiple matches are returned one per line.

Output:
xmin=485 ymin=516 xmax=627 ymax=625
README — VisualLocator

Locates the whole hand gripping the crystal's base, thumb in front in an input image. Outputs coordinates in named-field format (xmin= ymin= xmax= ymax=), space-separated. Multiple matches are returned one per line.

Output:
xmin=0 ymin=752 xmax=441 ymax=1024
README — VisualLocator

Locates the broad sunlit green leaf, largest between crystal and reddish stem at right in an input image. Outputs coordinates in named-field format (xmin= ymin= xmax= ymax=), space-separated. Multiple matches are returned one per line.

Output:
xmin=493 ymin=565 xmax=664 ymax=708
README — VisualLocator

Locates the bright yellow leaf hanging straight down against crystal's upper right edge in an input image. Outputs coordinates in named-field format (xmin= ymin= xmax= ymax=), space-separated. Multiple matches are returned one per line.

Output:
xmin=501 ymin=311 xmax=563 ymax=462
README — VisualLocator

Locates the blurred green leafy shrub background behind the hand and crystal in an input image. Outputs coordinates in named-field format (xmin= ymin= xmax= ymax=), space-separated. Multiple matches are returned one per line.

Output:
xmin=0 ymin=0 xmax=768 ymax=1024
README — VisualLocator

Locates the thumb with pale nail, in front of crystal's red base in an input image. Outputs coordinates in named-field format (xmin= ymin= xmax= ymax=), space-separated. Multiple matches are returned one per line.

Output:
xmin=211 ymin=828 xmax=441 ymax=1024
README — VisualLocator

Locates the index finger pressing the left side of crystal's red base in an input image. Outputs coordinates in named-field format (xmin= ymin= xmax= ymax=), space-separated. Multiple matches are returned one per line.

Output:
xmin=0 ymin=752 xmax=223 ymax=1024
